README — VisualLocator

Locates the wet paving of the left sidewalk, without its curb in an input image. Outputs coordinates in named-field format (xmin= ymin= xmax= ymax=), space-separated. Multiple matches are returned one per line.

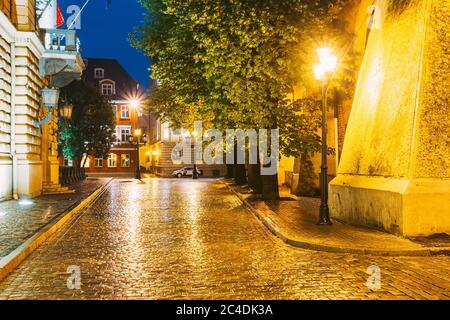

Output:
xmin=0 ymin=178 xmax=109 ymax=258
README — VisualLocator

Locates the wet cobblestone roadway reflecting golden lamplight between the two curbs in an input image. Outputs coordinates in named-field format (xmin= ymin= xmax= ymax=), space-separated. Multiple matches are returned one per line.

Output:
xmin=0 ymin=179 xmax=450 ymax=299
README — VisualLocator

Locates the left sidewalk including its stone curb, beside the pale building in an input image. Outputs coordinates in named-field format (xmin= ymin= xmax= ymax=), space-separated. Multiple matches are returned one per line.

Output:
xmin=0 ymin=178 xmax=111 ymax=280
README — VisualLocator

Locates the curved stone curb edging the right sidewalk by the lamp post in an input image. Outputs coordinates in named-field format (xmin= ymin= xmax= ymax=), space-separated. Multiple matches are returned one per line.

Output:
xmin=222 ymin=182 xmax=450 ymax=257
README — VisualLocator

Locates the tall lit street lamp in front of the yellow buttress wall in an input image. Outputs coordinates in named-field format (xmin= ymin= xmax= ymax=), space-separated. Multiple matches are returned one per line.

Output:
xmin=314 ymin=48 xmax=337 ymax=225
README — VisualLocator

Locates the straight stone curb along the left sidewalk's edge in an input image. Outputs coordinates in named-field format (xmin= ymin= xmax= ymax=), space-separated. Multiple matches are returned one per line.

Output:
xmin=0 ymin=178 xmax=114 ymax=281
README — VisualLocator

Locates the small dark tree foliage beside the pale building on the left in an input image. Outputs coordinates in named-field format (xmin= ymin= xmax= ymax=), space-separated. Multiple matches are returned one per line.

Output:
xmin=59 ymin=80 xmax=115 ymax=166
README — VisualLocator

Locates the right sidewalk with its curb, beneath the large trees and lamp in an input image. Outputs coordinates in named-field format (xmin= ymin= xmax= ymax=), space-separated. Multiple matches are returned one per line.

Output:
xmin=224 ymin=180 xmax=450 ymax=256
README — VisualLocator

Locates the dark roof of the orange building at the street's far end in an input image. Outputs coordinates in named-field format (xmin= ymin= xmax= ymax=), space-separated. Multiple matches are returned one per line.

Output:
xmin=84 ymin=58 xmax=146 ymax=100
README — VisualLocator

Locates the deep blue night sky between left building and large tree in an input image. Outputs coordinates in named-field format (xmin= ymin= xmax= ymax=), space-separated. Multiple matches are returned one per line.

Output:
xmin=58 ymin=0 xmax=149 ymax=87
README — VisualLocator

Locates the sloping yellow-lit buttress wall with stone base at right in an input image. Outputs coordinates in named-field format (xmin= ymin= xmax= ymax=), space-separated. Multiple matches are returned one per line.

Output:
xmin=330 ymin=0 xmax=450 ymax=235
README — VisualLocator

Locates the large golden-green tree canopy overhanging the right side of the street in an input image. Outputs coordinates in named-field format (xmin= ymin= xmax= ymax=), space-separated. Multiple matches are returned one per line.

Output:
xmin=132 ymin=0 xmax=348 ymax=198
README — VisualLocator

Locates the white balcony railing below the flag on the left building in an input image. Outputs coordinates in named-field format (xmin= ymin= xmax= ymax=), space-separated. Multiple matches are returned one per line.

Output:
xmin=44 ymin=29 xmax=81 ymax=53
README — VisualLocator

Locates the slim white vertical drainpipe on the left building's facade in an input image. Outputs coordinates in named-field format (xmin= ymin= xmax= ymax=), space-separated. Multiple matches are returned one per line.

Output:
xmin=10 ymin=42 xmax=19 ymax=200
